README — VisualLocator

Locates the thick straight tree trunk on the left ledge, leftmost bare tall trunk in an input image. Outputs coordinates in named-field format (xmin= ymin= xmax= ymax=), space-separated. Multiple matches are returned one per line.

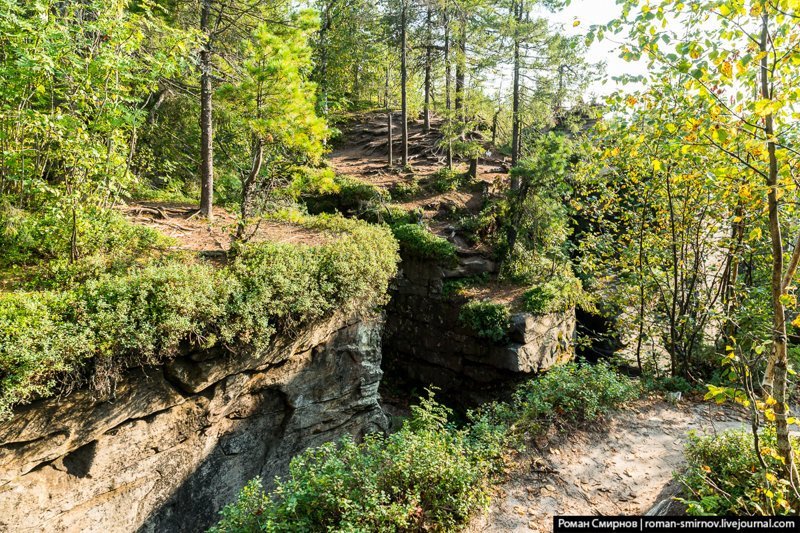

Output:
xmin=200 ymin=0 xmax=214 ymax=220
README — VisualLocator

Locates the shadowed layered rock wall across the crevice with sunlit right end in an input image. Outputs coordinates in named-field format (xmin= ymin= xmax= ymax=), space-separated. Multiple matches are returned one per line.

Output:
xmin=383 ymin=258 xmax=575 ymax=398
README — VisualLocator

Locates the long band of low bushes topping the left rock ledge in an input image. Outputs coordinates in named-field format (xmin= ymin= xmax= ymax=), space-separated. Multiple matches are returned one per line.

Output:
xmin=0 ymin=210 xmax=397 ymax=419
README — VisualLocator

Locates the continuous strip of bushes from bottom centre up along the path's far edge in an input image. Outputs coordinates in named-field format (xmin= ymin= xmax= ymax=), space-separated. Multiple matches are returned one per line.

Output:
xmin=212 ymin=363 xmax=636 ymax=533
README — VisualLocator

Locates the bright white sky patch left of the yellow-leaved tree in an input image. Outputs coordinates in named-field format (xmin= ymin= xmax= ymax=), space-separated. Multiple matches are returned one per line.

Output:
xmin=539 ymin=0 xmax=647 ymax=99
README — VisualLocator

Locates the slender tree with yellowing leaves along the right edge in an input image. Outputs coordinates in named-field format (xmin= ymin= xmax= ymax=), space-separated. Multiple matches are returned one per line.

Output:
xmin=608 ymin=0 xmax=800 ymax=487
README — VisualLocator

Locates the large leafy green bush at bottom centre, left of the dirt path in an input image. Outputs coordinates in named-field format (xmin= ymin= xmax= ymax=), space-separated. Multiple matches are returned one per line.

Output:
xmin=212 ymin=390 xmax=502 ymax=532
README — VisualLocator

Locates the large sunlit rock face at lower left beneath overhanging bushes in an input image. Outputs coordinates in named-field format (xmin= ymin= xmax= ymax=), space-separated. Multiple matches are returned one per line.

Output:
xmin=0 ymin=317 xmax=386 ymax=532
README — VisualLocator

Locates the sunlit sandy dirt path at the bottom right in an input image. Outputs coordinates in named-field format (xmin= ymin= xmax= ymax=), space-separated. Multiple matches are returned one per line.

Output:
xmin=467 ymin=400 xmax=743 ymax=533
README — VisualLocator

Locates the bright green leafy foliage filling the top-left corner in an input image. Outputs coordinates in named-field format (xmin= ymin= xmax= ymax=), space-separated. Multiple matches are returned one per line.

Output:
xmin=0 ymin=0 xmax=196 ymax=211
